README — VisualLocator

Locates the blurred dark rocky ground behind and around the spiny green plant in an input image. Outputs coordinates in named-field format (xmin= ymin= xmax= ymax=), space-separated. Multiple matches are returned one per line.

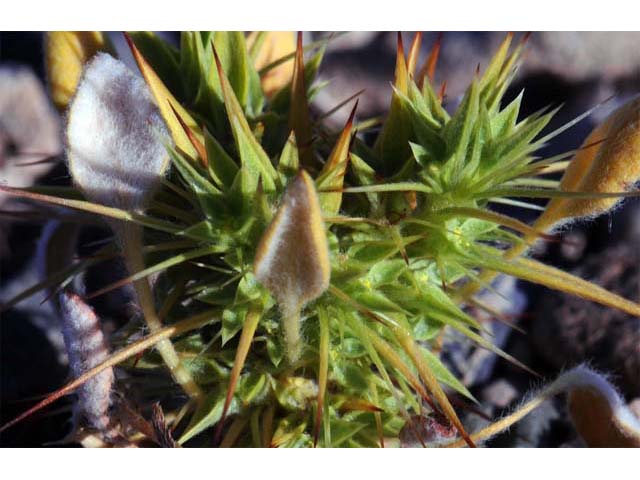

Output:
xmin=0 ymin=32 xmax=640 ymax=447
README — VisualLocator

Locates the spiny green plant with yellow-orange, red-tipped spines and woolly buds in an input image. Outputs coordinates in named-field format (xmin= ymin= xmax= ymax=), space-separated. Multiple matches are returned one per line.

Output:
xmin=1 ymin=32 xmax=640 ymax=447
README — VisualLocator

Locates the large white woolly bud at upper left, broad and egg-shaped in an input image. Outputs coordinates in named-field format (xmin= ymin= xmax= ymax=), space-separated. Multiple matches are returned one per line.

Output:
xmin=67 ymin=53 xmax=169 ymax=210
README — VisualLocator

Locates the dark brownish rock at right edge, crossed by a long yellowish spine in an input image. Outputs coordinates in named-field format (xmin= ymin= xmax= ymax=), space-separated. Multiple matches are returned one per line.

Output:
xmin=531 ymin=243 xmax=640 ymax=397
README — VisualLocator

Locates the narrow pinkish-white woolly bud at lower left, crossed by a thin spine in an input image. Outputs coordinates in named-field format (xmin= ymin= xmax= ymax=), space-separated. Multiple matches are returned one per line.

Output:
xmin=59 ymin=292 xmax=114 ymax=432
